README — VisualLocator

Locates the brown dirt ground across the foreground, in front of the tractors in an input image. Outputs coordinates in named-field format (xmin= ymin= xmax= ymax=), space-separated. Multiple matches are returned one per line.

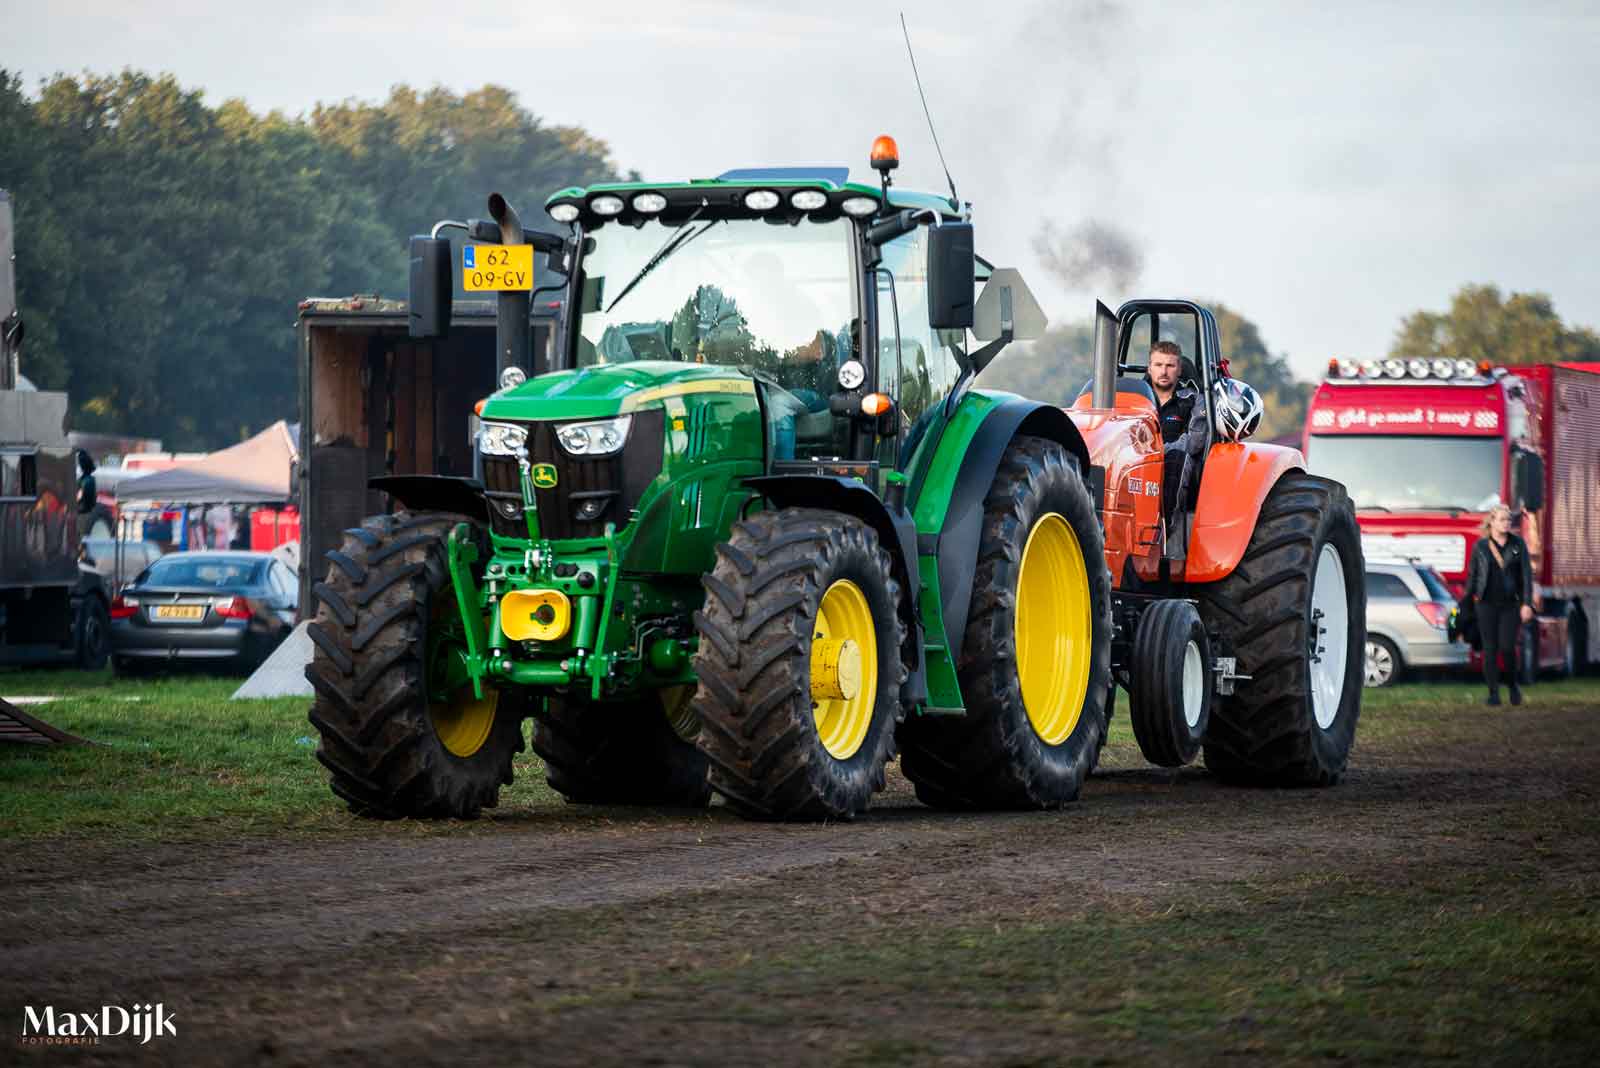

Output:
xmin=0 ymin=703 xmax=1600 ymax=1065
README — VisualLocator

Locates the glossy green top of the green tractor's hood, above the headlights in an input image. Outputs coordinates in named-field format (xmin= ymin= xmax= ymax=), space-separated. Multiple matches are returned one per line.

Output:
xmin=480 ymin=360 xmax=755 ymax=420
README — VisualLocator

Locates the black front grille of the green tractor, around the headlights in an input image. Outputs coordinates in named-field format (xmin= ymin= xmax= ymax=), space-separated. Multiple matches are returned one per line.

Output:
xmin=483 ymin=408 xmax=666 ymax=539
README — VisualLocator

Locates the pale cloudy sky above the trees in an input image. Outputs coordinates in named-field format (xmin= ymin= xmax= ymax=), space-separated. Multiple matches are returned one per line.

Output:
xmin=0 ymin=0 xmax=1600 ymax=377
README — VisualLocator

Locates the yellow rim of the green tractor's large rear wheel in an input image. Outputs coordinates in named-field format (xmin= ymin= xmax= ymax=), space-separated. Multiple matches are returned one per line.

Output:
xmin=1016 ymin=512 xmax=1094 ymax=745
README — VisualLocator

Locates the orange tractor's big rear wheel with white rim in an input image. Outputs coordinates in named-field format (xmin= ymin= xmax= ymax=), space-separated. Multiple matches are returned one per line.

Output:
xmin=1192 ymin=472 xmax=1366 ymax=787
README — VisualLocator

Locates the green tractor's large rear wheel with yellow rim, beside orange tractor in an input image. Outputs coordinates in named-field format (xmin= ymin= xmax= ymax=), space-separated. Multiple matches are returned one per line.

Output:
xmin=901 ymin=436 xmax=1110 ymax=809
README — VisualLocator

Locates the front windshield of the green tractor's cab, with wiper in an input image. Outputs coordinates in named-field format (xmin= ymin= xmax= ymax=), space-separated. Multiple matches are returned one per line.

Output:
xmin=576 ymin=219 xmax=859 ymax=456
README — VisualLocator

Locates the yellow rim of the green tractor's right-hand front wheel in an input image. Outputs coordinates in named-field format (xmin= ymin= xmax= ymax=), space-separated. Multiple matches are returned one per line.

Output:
xmin=811 ymin=579 xmax=878 ymax=759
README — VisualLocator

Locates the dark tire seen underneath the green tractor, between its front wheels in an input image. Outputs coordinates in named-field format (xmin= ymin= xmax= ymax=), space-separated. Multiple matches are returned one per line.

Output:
xmin=533 ymin=687 xmax=710 ymax=809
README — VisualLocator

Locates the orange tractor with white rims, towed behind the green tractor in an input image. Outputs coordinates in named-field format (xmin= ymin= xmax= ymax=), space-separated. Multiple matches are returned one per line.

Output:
xmin=1067 ymin=301 xmax=1366 ymax=785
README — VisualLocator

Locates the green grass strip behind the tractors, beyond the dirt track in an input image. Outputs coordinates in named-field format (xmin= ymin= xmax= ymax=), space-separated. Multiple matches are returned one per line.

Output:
xmin=0 ymin=671 xmax=1600 ymax=839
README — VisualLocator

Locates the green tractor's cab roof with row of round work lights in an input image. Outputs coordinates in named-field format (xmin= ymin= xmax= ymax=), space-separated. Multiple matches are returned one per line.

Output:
xmin=544 ymin=166 xmax=962 ymax=229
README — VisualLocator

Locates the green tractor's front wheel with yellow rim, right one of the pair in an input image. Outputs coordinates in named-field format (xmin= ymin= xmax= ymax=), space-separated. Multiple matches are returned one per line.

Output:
xmin=694 ymin=508 xmax=906 ymax=820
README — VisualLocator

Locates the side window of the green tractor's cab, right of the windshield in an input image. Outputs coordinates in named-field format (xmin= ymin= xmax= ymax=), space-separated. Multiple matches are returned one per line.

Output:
xmin=878 ymin=227 xmax=962 ymax=467
